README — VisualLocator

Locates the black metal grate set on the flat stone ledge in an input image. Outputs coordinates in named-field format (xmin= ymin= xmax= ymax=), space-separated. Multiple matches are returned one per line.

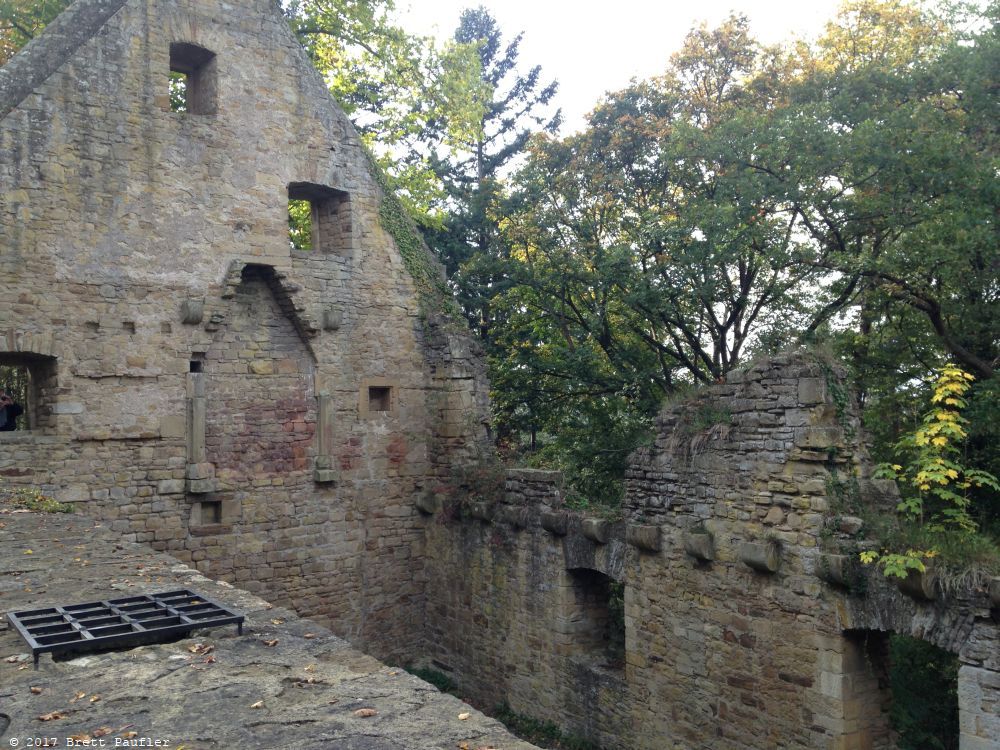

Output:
xmin=7 ymin=589 xmax=243 ymax=669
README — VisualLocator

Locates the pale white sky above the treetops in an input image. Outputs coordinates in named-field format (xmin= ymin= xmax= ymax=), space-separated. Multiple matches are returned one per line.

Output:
xmin=397 ymin=0 xmax=840 ymax=132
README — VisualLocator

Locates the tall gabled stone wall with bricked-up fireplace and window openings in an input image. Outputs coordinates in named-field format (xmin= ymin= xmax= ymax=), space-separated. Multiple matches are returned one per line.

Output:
xmin=0 ymin=0 xmax=486 ymax=658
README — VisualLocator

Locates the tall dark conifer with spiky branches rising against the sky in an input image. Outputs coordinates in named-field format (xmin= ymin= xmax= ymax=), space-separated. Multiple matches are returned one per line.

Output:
xmin=428 ymin=6 xmax=561 ymax=340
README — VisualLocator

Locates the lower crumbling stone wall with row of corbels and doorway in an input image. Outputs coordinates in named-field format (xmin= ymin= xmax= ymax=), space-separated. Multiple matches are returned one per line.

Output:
xmin=426 ymin=355 xmax=1000 ymax=750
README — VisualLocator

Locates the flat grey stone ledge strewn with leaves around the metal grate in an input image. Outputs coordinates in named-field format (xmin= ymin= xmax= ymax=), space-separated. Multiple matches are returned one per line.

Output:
xmin=0 ymin=509 xmax=534 ymax=750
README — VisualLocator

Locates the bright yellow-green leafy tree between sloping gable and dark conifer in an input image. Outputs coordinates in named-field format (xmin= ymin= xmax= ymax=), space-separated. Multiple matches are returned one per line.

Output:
xmin=284 ymin=0 xmax=488 ymax=224
